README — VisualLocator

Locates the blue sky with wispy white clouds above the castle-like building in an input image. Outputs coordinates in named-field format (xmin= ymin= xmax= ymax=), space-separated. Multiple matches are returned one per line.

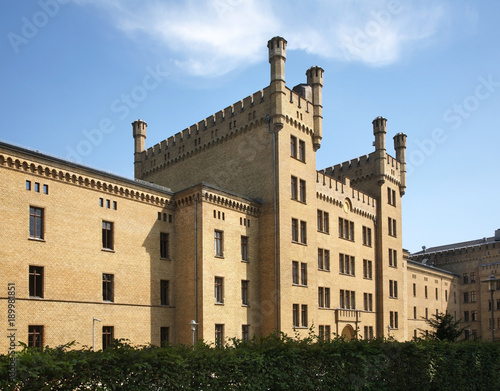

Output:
xmin=0 ymin=0 xmax=500 ymax=252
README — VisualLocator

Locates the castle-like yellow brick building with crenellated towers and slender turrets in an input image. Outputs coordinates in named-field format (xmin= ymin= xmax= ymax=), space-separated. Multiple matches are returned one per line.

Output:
xmin=0 ymin=37 xmax=456 ymax=351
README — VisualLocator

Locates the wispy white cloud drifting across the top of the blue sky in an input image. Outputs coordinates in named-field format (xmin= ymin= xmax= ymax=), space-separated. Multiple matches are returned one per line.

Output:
xmin=74 ymin=0 xmax=472 ymax=77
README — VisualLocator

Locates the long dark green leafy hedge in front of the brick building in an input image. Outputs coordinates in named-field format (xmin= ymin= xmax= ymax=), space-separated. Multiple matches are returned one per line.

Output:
xmin=0 ymin=336 xmax=500 ymax=391
